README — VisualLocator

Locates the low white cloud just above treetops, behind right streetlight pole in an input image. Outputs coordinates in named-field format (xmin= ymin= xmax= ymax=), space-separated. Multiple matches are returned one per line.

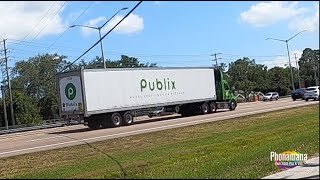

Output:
xmin=262 ymin=50 xmax=302 ymax=69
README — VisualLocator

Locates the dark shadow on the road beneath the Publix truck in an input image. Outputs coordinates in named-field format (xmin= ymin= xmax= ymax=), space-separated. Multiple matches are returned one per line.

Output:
xmin=48 ymin=111 xmax=224 ymax=134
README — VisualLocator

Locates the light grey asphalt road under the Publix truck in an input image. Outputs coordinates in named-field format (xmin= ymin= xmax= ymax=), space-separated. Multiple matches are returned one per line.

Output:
xmin=0 ymin=98 xmax=319 ymax=158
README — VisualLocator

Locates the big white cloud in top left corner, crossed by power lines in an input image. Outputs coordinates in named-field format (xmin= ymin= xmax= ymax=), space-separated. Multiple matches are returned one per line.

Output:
xmin=0 ymin=1 xmax=65 ymax=39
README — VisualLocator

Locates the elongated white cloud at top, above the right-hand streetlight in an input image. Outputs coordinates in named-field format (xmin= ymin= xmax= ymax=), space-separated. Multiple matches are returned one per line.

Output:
xmin=240 ymin=1 xmax=307 ymax=27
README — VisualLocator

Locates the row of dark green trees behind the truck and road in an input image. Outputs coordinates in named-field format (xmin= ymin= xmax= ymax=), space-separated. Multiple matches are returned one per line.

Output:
xmin=0 ymin=48 xmax=319 ymax=127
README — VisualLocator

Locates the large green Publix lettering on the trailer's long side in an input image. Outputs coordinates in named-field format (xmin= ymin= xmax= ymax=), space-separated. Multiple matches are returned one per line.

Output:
xmin=140 ymin=78 xmax=176 ymax=92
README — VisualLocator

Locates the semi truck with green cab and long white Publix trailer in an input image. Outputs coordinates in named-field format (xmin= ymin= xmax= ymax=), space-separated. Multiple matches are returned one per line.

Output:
xmin=57 ymin=67 xmax=237 ymax=129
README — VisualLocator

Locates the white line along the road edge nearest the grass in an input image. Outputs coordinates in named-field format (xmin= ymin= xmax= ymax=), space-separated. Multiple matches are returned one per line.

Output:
xmin=0 ymin=103 xmax=316 ymax=155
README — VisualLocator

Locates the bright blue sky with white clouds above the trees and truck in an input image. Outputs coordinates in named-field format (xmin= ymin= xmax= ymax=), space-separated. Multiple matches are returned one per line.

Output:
xmin=0 ymin=1 xmax=319 ymax=76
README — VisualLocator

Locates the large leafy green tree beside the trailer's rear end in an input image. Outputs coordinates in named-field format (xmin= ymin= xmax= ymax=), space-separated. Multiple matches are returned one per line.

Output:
xmin=12 ymin=54 xmax=69 ymax=119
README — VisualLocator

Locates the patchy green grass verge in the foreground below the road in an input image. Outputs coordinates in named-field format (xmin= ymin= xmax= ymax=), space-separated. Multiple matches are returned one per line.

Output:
xmin=0 ymin=105 xmax=319 ymax=179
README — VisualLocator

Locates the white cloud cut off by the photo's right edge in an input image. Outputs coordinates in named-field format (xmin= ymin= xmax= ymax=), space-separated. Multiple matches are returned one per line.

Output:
xmin=289 ymin=3 xmax=319 ymax=32
